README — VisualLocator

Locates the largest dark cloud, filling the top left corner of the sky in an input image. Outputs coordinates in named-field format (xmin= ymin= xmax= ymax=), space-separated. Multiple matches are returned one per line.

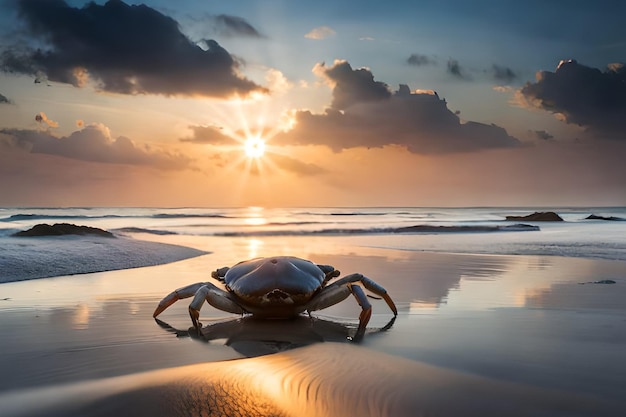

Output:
xmin=0 ymin=0 xmax=265 ymax=97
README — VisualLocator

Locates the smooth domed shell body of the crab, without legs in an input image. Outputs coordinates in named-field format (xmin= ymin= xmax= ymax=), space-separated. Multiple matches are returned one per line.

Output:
xmin=223 ymin=256 xmax=326 ymax=317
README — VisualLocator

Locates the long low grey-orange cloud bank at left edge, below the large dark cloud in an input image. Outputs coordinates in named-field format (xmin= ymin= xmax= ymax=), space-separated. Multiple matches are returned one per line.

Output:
xmin=0 ymin=124 xmax=191 ymax=169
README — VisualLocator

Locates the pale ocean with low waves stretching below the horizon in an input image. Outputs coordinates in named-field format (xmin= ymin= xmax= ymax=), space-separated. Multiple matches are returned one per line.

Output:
xmin=0 ymin=207 xmax=626 ymax=249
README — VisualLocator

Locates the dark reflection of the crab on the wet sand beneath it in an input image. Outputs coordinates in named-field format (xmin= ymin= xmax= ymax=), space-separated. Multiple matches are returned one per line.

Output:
xmin=155 ymin=316 xmax=396 ymax=357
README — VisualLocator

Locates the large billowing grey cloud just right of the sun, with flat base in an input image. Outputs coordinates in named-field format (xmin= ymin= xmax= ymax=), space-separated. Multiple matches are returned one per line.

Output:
xmin=272 ymin=61 xmax=520 ymax=154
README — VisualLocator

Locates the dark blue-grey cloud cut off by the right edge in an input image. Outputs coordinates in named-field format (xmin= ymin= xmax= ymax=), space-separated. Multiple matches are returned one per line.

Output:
xmin=520 ymin=60 xmax=626 ymax=139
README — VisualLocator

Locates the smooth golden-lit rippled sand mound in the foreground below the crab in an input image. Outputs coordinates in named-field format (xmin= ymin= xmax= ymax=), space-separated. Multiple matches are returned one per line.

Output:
xmin=0 ymin=343 xmax=621 ymax=417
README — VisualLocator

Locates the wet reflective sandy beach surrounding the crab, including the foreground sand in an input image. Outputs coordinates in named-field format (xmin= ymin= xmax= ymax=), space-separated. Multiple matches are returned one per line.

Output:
xmin=0 ymin=210 xmax=626 ymax=416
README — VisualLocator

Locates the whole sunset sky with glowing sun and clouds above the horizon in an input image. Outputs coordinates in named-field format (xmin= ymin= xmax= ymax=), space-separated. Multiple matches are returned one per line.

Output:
xmin=0 ymin=0 xmax=626 ymax=207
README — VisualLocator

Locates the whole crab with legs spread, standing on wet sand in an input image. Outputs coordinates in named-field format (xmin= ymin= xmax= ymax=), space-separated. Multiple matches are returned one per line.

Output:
xmin=152 ymin=256 xmax=398 ymax=336
